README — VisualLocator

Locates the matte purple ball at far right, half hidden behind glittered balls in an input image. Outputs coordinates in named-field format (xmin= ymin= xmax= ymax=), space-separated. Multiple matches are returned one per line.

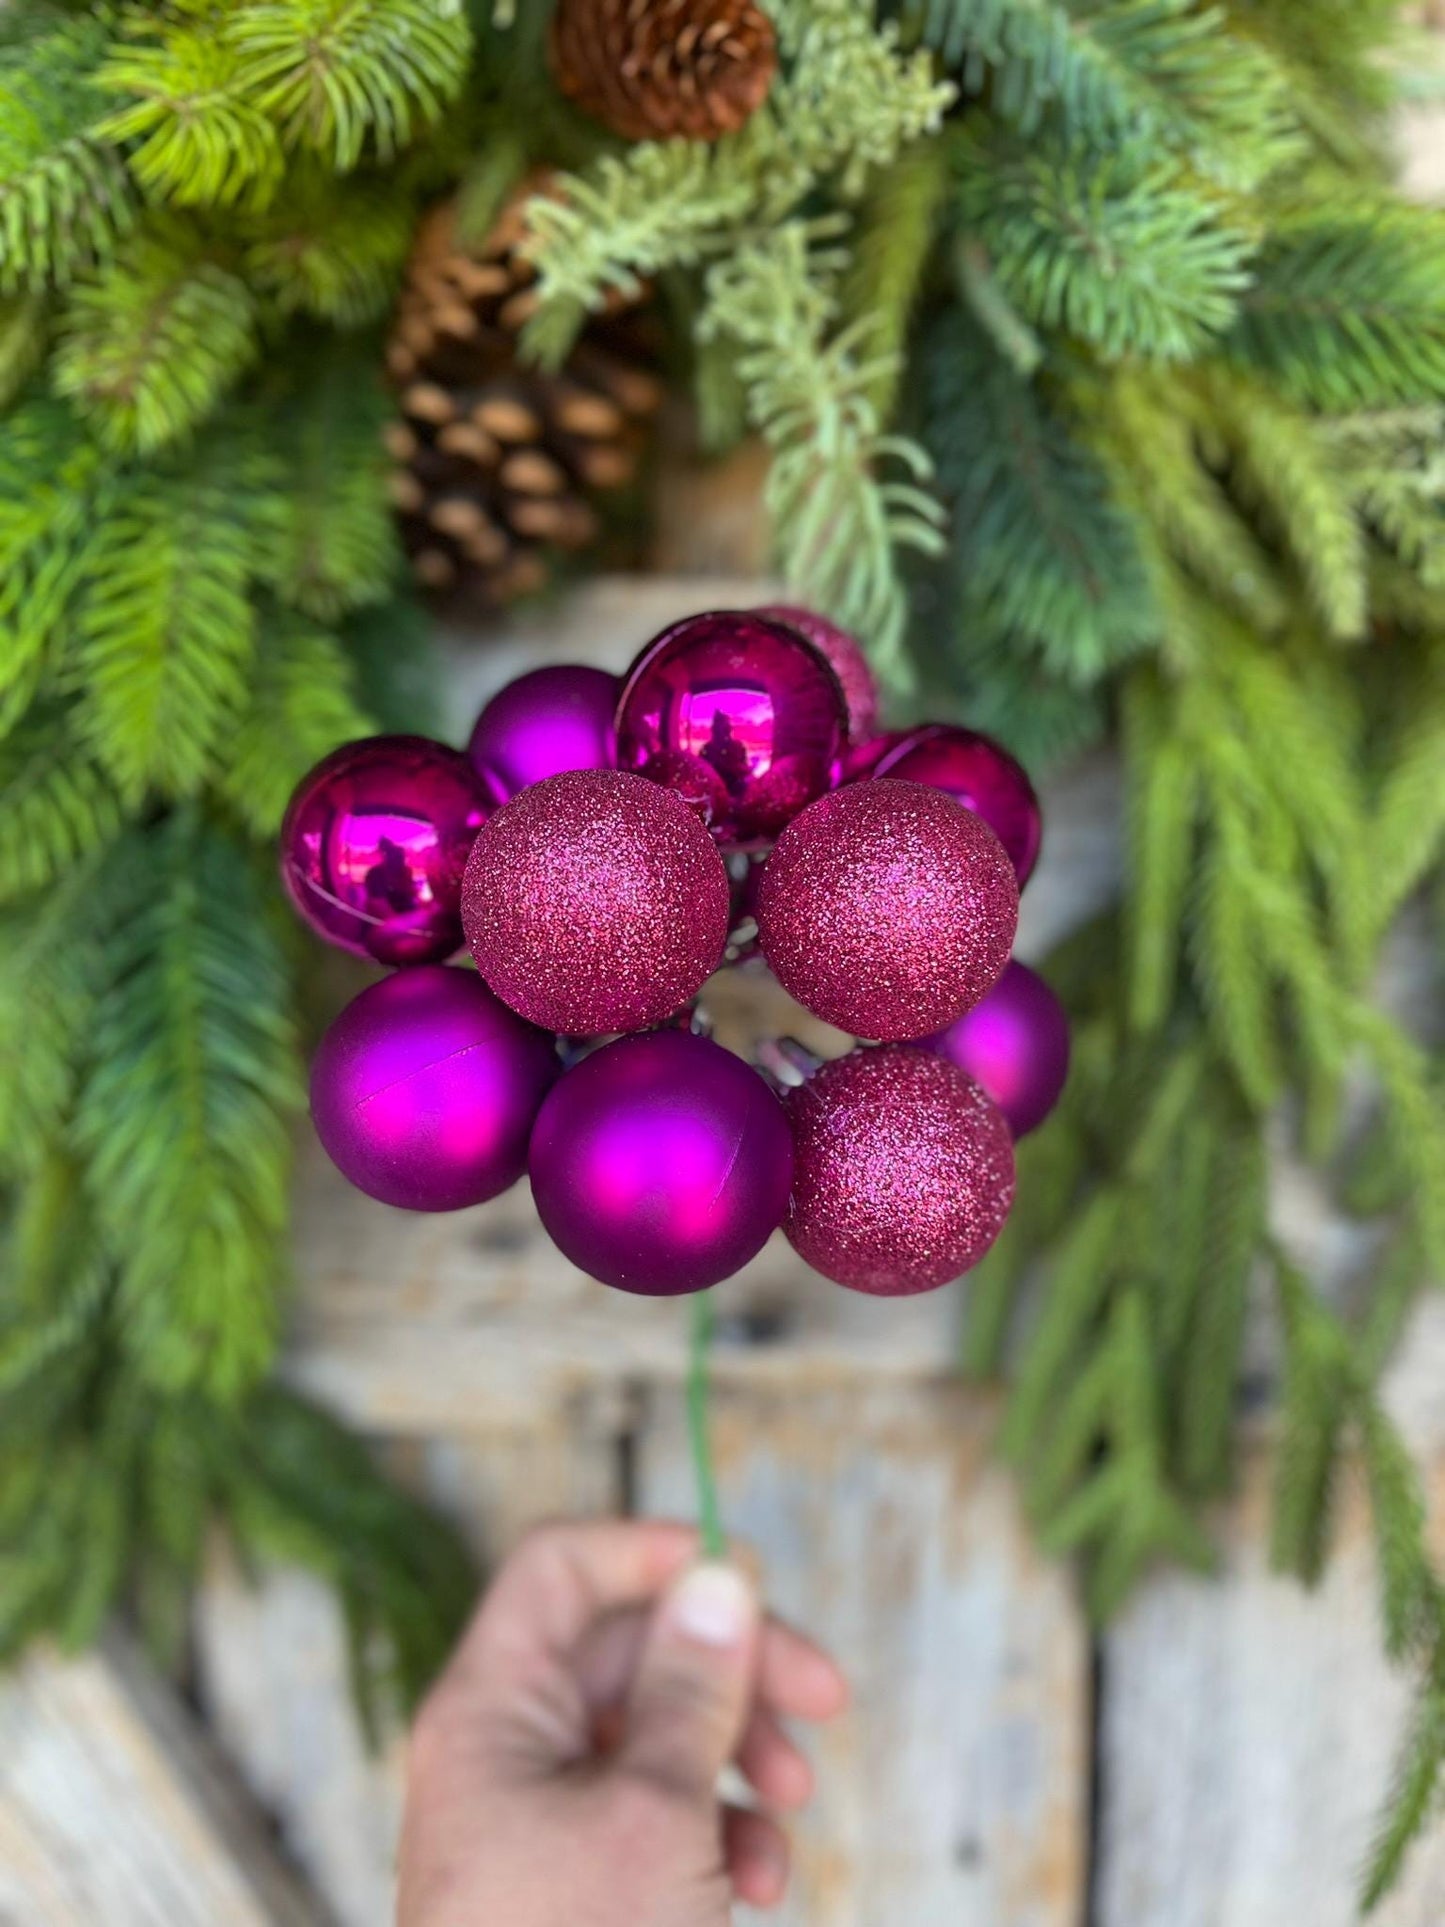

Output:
xmin=921 ymin=964 xmax=1069 ymax=1137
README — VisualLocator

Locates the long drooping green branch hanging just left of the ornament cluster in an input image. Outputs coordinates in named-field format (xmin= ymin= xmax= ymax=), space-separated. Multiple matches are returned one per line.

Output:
xmin=77 ymin=813 xmax=301 ymax=1397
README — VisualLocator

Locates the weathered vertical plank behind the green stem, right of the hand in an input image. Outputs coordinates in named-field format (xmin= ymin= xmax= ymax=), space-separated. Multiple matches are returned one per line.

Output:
xmin=638 ymin=1384 xmax=1089 ymax=1927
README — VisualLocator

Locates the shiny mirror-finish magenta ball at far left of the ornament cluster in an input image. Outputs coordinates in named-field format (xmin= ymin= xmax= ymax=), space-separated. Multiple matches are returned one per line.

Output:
xmin=281 ymin=736 xmax=487 ymax=964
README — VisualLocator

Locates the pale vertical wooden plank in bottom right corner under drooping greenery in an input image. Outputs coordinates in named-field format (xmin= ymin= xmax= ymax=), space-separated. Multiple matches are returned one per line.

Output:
xmin=1098 ymin=1441 xmax=1445 ymax=1927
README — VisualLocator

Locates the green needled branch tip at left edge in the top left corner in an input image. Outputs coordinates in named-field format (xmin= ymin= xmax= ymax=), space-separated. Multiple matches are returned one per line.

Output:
xmin=0 ymin=17 xmax=133 ymax=293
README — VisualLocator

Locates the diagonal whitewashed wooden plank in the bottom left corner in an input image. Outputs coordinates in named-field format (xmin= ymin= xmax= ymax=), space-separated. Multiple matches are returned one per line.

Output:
xmin=0 ymin=1642 xmax=322 ymax=1927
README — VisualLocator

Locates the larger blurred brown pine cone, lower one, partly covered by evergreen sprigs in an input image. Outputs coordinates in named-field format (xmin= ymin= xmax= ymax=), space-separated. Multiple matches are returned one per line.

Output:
xmin=387 ymin=194 xmax=663 ymax=603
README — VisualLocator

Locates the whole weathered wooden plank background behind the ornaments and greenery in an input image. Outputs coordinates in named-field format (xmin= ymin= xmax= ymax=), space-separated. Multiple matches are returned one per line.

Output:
xmin=0 ymin=580 xmax=1445 ymax=1927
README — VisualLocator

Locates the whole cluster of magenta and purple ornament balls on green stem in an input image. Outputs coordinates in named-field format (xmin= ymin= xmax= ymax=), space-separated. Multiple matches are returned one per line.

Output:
xmin=281 ymin=609 xmax=1067 ymax=1295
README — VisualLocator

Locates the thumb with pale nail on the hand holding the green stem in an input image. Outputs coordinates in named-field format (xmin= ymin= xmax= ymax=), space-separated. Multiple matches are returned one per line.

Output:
xmin=622 ymin=1565 xmax=759 ymax=1800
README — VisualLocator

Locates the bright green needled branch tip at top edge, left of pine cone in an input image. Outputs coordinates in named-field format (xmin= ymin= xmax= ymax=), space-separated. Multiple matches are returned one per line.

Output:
xmin=225 ymin=0 xmax=472 ymax=172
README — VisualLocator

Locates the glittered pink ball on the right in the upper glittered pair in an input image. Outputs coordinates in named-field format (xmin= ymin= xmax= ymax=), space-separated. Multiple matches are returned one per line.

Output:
xmin=757 ymin=780 xmax=1019 ymax=1039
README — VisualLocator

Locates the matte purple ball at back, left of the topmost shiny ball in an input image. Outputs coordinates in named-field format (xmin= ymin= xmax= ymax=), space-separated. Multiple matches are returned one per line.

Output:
xmin=466 ymin=663 xmax=618 ymax=804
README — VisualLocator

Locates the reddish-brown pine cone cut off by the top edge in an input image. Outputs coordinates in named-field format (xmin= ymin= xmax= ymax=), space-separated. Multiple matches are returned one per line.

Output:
xmin=551 ymin=0 xmax=778 ymax=141
